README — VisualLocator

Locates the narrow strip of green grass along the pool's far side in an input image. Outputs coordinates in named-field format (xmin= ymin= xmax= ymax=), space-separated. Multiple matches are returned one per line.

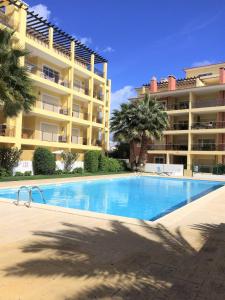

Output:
xmin=0 ymin=171 xmax=131 ymax=182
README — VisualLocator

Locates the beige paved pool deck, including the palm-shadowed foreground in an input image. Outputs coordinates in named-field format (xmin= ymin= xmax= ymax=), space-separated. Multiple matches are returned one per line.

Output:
xmin=0 ymin=175 xmax=225 ymax=300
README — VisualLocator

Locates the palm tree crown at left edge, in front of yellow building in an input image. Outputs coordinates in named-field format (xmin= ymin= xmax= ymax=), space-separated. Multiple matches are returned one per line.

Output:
xmin=0 ymin=29 xmax=35 ymax=117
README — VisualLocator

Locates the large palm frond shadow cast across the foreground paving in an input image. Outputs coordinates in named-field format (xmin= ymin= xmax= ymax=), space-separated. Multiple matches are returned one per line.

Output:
xmin=5 ymin=221 xmax=225 ymax=300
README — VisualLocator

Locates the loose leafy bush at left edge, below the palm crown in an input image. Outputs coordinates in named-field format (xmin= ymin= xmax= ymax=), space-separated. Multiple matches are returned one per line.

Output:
xmin=0 ymin=148 xmax=22 ymax=176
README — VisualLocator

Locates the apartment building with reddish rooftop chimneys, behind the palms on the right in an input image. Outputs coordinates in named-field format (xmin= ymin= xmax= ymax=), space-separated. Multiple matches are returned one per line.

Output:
xmin=136 ymin=63 xmax=225 ymax=174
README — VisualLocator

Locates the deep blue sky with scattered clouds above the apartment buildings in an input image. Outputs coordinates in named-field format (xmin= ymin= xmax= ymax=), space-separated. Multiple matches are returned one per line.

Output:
xmin=26 ymin=0 xmax=225 ymax=109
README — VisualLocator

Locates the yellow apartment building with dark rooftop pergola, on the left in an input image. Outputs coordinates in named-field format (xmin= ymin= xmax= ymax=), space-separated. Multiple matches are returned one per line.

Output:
xmin=0 ymin=0 xmax=111 ymax=166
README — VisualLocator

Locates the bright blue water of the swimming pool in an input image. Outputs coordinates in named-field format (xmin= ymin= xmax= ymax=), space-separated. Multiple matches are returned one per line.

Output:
xmin=0 ymin=176 xmax=223 ymax=220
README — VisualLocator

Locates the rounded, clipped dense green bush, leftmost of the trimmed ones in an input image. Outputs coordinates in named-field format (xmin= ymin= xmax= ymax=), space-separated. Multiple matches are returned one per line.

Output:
xmin=33 ymin=147 xmax=56 ymax=175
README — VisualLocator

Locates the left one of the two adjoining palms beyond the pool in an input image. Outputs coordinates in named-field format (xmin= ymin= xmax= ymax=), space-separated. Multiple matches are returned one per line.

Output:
xmin=110 ymin=103 xmax=140 ymax=168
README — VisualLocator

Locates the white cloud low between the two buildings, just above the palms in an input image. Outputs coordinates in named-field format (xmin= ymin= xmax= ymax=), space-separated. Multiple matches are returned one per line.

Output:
xmin=111 ymin=85 xmax=136 ymax=111
